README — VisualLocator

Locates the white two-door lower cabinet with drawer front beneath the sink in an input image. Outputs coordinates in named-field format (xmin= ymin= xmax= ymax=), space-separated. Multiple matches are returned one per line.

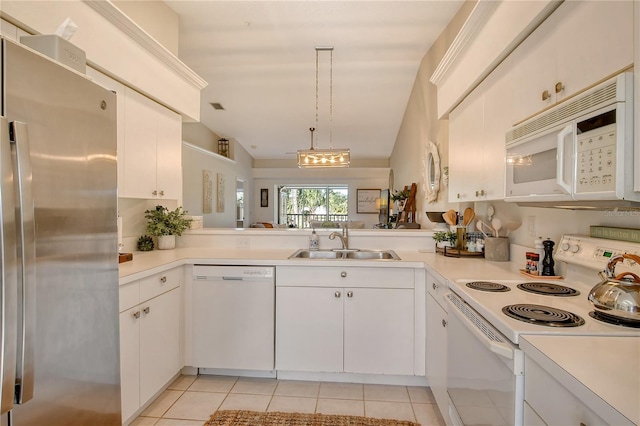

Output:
xmin=276 ymin=267 xmax=414 ymax=375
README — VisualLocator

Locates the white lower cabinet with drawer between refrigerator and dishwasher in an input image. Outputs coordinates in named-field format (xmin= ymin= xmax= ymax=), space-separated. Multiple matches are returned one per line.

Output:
xmin=120 ymin=268 xmax=182 ymax=421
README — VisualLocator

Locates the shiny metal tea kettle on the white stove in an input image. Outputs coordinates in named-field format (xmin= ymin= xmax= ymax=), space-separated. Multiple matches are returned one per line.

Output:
xmin=588 ymin=254 xmax=640 ymax=321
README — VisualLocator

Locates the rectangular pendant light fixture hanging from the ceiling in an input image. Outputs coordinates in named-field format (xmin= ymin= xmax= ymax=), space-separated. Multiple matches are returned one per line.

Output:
xmin=298 ymin=47 xmax=351 ymax=168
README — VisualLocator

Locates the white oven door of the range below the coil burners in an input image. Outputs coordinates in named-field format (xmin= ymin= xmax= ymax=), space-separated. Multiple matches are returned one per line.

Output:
xmin=447 ymin=294 xmax=524 ymax=426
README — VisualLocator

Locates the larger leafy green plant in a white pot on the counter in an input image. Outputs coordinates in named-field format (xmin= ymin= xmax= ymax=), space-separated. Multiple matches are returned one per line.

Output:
xmin=144 ymin=206 xmax=192 ymax=250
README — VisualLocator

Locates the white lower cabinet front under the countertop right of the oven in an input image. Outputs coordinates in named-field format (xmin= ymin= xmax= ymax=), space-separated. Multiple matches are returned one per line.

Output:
xmin=524 ymin=357 xmax=608 ymax=426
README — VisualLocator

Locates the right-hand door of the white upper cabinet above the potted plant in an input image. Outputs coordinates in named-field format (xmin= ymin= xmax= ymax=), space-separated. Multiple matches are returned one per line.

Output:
xmin=156 ymin=105 xmax=182 ymax=200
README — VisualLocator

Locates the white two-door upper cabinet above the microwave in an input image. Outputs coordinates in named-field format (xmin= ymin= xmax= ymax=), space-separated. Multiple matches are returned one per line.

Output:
xmin=511 ymin=1 xmax=633 ymax=122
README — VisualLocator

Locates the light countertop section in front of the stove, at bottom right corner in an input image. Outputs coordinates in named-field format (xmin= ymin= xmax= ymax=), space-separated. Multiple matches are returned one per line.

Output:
xmin=520 ymin=336 xmax=640 ymax=425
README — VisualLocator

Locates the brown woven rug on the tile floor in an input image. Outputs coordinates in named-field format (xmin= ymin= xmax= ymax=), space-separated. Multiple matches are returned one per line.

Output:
xmin=204 ymin=410 xmax=420 ymax=426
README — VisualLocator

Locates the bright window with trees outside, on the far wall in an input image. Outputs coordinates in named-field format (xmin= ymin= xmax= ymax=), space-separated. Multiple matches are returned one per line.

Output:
xmin=278 ymin=185 xmax=349 ymax=228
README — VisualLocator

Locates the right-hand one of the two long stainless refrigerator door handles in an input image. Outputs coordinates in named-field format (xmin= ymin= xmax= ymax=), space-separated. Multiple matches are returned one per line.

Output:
xmin=10 ymin=121 xmax=36 ymax=404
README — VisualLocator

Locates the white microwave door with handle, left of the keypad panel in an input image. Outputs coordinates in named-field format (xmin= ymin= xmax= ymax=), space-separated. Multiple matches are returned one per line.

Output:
xmin=505 ymin=123 xmax=575 ymax=202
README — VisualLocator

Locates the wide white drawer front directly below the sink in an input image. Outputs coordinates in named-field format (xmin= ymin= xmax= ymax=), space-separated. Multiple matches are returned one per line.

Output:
xmin=276 ymin=266 xmax=415 ymax=288
